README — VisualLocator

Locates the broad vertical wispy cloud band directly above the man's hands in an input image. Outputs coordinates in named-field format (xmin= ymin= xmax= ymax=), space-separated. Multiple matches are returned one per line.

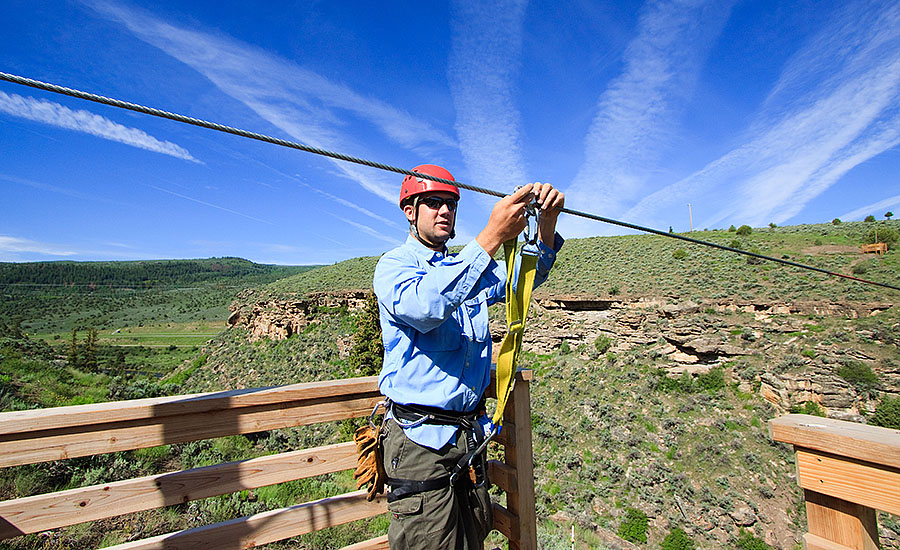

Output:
xmin=448 ymin=0 xmax=526 ymax=198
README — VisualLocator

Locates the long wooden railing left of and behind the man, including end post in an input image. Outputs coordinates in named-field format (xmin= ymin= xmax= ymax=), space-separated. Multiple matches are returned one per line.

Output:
xmin=0 ymin=371 xmax=537 ymax=550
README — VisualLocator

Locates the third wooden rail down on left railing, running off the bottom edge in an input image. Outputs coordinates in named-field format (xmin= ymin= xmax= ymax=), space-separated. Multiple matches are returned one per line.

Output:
xmin=107 ymin=490 xmax=387 ymax=550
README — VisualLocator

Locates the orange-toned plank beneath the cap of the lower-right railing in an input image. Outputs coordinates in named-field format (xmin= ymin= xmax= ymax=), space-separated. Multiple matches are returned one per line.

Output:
xmin=797 ymin=449 xmax=900 ymax=515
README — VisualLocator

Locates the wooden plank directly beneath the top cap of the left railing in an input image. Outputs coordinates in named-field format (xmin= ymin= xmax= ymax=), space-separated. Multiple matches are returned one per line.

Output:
xmin=0 ymin=393 xmax=381 ymax=467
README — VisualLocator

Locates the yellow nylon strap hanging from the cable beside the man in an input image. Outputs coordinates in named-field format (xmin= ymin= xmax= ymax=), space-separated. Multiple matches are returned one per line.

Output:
xmin=492 ymin=238 xmax=538 ymax=427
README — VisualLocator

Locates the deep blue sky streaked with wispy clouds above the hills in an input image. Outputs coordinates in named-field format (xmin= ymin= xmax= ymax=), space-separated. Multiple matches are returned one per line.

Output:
xmin=0 ymin=0 xmax=900 ymax=264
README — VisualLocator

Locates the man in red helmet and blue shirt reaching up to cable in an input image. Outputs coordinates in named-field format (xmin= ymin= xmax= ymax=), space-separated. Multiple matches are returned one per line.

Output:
xmin=374 ymin=164 xmax=564 ymax=550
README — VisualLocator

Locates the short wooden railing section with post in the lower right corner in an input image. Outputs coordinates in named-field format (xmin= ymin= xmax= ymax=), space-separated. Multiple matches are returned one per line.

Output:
xmin=769 ymin=414 xmax=900 ymax=550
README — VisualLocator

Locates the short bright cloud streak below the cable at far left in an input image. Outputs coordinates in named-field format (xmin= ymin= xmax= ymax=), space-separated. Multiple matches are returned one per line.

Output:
xmin=0 ymin=92 xmax=200 ymax=163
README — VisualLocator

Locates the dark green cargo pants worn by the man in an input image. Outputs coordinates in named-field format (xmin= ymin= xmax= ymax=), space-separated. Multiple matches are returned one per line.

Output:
xmin=383 ymin=419 xmax=493 ymax=550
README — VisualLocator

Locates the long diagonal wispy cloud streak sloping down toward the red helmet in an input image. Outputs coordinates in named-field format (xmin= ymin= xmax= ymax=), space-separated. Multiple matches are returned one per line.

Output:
xmin=87 ymin=0 xmax=455 ymax=202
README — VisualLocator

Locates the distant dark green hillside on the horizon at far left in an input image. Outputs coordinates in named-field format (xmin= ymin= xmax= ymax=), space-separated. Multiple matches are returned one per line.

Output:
xmin=0 ymin=258 xmax=315 ymax=334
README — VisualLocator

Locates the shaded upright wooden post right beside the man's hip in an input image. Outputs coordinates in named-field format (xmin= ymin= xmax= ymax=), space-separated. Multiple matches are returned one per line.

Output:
xmin=504 ymin=371 xmax=537 ymax=550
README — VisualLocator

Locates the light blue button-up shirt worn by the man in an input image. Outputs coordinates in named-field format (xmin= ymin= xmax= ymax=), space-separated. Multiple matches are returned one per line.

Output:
xmin=374 ymin=234 xmax=563 ymax=449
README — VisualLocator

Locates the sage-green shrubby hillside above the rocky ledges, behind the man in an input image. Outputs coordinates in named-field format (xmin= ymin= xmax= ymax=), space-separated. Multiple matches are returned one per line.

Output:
xmin=263 ymin=221 xmax=900 ymax=301
